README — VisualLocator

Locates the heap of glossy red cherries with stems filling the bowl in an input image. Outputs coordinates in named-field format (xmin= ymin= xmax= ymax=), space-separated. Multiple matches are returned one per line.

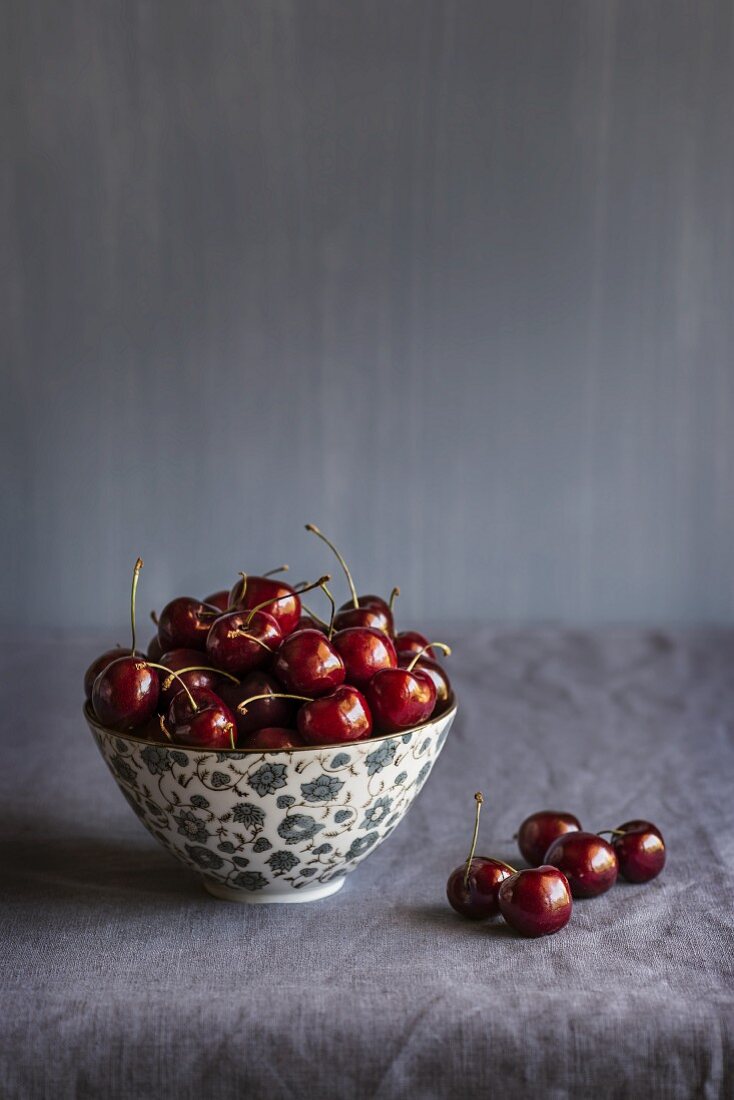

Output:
xmin=85 ymin=524 xmax=451 ymax=750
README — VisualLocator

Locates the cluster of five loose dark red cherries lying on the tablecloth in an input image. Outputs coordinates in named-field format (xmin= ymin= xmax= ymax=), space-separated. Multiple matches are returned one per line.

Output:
xmin=446 ymin=792 xmax=666 ymax=936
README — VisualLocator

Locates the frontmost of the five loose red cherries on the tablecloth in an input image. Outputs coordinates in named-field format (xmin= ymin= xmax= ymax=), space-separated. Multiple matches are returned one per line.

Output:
xmin=497 ymin=866 xmax=573 ymax=937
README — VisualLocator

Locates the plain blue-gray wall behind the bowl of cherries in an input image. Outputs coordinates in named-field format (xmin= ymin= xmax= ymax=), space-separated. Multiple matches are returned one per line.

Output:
xmin=0 ymin=0 xmax=734 ymax=638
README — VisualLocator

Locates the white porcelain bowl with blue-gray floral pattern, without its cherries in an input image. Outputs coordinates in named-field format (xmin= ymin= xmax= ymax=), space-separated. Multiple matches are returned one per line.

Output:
xmin=85 ymin=703 xmax=457 ymax=902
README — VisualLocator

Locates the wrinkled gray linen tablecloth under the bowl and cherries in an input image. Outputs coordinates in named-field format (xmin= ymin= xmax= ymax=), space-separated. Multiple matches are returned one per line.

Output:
xmin=0 ymin=628 xmax=734 ymax=1100
